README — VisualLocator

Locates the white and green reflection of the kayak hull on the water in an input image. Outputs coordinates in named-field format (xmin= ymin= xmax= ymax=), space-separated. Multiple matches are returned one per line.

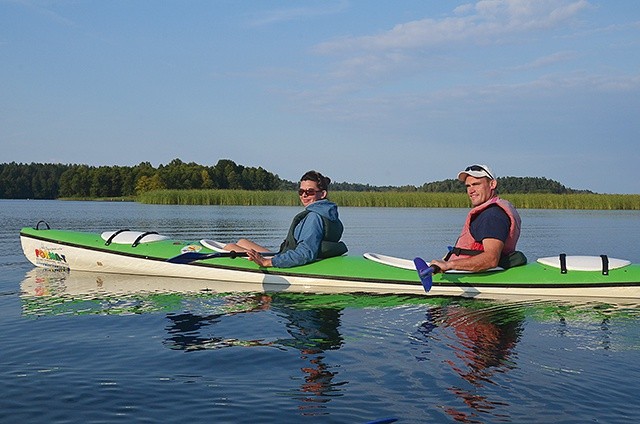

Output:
xmin=20 ymin=268 xmax=640 ymax=320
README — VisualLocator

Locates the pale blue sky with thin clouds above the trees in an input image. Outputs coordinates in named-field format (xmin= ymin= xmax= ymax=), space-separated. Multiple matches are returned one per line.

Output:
xmin=0 ymin=0 xmax=640 ymax=193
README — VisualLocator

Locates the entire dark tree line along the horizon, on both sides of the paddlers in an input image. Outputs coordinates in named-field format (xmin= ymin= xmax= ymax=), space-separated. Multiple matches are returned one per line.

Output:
xmin=0 ymin=159 xmax=588 ymax=199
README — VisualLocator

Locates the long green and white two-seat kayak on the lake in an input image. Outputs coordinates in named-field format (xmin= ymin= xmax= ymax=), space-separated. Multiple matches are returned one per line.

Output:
xmin=20 ymin=224 xmax=640 ymax=299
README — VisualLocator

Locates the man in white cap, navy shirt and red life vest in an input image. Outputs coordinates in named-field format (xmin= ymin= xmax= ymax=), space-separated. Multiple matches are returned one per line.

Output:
xmin=431 ymin=165 xmax=526 ymax=272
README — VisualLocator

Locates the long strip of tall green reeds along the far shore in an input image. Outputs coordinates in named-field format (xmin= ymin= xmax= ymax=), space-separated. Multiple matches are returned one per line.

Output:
xmin=137 ymin=190 xmax=640 ymax=210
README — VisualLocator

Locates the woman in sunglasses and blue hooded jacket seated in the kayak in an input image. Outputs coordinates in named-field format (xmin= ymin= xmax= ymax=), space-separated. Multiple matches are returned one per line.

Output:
xmin=224 ymin=171 xmax=347 ymax=268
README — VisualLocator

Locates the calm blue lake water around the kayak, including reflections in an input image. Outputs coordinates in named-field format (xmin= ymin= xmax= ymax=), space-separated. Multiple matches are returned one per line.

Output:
xmin=0 ymin=200 xmax=640 ymax=423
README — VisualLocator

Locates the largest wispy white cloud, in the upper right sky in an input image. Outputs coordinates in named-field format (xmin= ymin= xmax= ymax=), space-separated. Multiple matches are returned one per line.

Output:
xmin=314 ymin=0 xmax=590 ymax=83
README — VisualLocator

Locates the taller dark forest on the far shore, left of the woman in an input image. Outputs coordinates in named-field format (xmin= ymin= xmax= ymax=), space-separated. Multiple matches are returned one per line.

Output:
xmin=0 ymin=159 xmax=284 ymax=199
